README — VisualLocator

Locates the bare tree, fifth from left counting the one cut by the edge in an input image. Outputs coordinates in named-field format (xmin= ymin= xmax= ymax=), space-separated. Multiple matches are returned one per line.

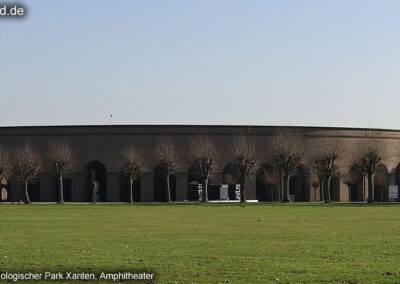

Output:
xmin=156 ymin=137 xmax=181 ymax=202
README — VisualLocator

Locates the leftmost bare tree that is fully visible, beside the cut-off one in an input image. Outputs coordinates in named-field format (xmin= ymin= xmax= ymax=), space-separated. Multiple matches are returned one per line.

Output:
xmin=15 ymin=143 xmax=42 ymax=203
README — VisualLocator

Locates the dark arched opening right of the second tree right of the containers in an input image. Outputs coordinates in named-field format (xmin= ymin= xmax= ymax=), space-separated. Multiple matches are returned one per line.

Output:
xmin=289 ymin=165 xmax=310 ymax=201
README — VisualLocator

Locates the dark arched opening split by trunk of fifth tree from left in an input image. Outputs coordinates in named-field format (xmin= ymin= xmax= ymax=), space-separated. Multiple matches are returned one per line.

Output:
xmin=154 ymin=165 xmax=176 ymax=202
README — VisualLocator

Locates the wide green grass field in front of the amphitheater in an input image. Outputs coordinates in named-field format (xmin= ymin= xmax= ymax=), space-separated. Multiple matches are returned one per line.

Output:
xmin=0 ymin=204 xmax=400 ymax=283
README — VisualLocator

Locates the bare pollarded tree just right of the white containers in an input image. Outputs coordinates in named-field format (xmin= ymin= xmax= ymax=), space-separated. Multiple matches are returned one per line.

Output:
xmin=233 ymin=135 xmax=258 ymax=202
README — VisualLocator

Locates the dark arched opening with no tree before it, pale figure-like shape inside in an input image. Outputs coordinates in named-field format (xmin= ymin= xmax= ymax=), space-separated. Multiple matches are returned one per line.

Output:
xmin=86 ymin=161 xmax=107 ymax=202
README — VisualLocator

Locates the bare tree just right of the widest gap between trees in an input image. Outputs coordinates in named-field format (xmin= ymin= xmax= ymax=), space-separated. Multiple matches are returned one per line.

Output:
xmin=121 ymin=147 xmax=143 ymax=203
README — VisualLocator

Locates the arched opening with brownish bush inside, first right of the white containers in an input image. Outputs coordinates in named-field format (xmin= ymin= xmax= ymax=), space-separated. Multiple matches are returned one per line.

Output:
xmin=256 ymin=163 xmax=279 ymax=201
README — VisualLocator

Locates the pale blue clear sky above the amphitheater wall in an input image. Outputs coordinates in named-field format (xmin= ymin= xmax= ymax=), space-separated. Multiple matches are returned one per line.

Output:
xmin=0 ymin=0 xmax=400 ymax=129
